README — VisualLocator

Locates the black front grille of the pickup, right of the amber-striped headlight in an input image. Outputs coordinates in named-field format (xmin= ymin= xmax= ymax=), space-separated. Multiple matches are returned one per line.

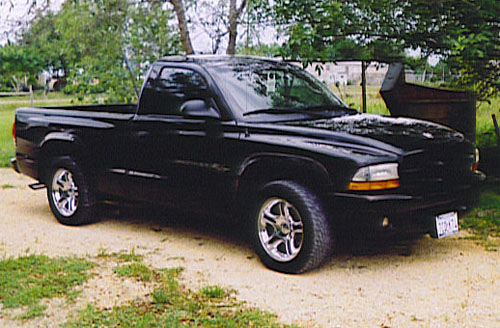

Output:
xmin=399 ymin=143 xmax=474 ymax=197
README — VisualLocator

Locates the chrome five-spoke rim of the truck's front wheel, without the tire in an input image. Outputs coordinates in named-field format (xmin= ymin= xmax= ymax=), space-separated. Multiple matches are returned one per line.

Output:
xmin=258 ymin=198 xmax=304 ymax=262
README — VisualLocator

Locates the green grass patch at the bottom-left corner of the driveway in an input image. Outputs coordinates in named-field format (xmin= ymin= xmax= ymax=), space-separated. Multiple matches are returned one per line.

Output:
xmin=0 ymin=255 xmax=93 ymax=319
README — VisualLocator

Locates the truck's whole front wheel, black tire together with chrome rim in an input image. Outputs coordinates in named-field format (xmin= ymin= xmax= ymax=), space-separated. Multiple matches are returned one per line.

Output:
xmin=250 ymin=181 xmax=335 ymax=273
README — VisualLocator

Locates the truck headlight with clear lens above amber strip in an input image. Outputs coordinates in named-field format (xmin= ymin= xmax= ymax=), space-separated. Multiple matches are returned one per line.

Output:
xmin=349 ymin=163 xmax=399 ymax=190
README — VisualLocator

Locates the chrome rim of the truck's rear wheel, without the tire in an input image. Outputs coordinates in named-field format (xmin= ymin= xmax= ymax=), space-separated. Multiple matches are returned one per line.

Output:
xmin=52 ymin=168 xmax=78 ymax=217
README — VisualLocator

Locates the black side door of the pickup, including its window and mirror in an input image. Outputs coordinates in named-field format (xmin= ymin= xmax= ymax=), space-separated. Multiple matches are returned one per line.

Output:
xmin=128 ymin=66 xmax=224 ymax=211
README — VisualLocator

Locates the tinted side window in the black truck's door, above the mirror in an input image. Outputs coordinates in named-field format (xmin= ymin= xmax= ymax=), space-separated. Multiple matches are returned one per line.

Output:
xmin=139 ymin=67 xmax=208 ymax=115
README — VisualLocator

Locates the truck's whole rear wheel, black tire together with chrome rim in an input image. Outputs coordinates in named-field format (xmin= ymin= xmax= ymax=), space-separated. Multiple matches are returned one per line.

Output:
xmin=45 ymin=156 xmax=96 ymax=226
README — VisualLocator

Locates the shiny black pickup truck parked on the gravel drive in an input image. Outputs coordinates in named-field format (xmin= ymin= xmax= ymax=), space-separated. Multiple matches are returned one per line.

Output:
xmin=12 ymin=56 xmax=480 ymax=273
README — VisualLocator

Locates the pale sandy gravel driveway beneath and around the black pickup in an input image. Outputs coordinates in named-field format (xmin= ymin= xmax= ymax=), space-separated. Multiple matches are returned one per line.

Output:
xmin=0 ymin=169 xmax=500 ymax=327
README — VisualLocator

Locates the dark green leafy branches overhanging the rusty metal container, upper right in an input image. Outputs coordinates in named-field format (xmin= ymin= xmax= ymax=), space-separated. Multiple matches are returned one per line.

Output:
xmin=274 ymin=0 xmax=500 ymax=98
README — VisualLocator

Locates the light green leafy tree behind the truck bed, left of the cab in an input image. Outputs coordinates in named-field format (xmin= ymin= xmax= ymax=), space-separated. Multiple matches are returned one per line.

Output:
xmin=20 ymin=0 xmax=183 ymax=102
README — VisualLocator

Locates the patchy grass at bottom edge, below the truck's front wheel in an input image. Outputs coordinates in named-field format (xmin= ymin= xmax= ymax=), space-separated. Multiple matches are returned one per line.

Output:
xmin=64 ymin=263 xmax=300 ymax=328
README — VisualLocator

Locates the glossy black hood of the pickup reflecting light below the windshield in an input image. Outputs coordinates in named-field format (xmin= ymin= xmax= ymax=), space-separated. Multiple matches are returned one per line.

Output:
xmin=285 ymin=114 xmax=464 ymax=151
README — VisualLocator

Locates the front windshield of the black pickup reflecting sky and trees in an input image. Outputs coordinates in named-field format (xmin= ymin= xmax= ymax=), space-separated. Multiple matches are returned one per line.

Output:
xmin=207 ymin=60 xmax=347 ymax=116
